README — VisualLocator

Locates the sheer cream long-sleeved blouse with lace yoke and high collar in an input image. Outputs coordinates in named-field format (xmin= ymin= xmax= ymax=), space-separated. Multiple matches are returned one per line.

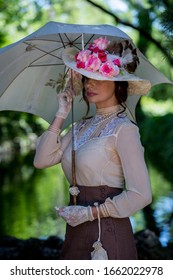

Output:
xmin=34 ymin=106 xmax=152 ymax=218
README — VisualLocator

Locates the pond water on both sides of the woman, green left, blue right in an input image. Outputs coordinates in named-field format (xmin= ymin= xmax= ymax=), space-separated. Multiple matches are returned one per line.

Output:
xmin=0 ymin=165 xmax=173 ymax=246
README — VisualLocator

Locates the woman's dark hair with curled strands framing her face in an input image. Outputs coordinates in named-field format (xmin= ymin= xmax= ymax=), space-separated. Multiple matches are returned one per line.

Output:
xmin=82 ymin=76 xmax=128 ymax=116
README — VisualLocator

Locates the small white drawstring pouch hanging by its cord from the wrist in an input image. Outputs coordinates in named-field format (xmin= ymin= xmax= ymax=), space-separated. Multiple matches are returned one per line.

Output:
xmin=91 ymin=203 xmax=108 ymax=260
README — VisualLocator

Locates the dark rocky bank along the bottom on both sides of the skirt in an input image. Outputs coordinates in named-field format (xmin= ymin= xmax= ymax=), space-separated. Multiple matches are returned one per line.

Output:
xmin=0 ymin=229 xmax=173 ymax=260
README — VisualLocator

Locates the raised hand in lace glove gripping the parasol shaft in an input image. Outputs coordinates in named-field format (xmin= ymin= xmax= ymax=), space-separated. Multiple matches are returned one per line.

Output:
xmin=56 ymin=87 xmax=75 ymax=119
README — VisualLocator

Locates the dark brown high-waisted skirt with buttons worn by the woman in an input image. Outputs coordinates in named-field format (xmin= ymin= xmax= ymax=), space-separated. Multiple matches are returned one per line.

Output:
xmin=60 ymin=186 xmax=137 ymax=260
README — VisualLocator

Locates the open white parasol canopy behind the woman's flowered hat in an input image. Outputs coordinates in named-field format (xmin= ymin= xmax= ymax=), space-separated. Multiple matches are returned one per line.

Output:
xmin=0 ymin=22 xmax=172 ymax=127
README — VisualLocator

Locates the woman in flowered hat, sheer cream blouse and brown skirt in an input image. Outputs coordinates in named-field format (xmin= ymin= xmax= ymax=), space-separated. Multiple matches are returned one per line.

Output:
xmin=34 ymin=38 xmax=151 ymax=260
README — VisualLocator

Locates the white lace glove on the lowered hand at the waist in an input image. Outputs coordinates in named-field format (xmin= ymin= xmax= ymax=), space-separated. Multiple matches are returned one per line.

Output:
xmin=55 ymin=205 xmax=94 ymax=227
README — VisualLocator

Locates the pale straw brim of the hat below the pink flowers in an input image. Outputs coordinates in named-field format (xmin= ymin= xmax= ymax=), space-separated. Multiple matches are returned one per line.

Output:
xmin=62 ymin=47 xmax=151 ymax=95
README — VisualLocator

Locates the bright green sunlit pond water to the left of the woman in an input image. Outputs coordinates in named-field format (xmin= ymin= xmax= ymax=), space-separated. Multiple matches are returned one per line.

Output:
xmin=0 ymin=166 xmax=68 ymax=239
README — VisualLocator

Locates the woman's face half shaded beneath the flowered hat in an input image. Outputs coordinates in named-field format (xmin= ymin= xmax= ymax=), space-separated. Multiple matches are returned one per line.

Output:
xmin=84 ymin=78 xmax=118 ymax=108
